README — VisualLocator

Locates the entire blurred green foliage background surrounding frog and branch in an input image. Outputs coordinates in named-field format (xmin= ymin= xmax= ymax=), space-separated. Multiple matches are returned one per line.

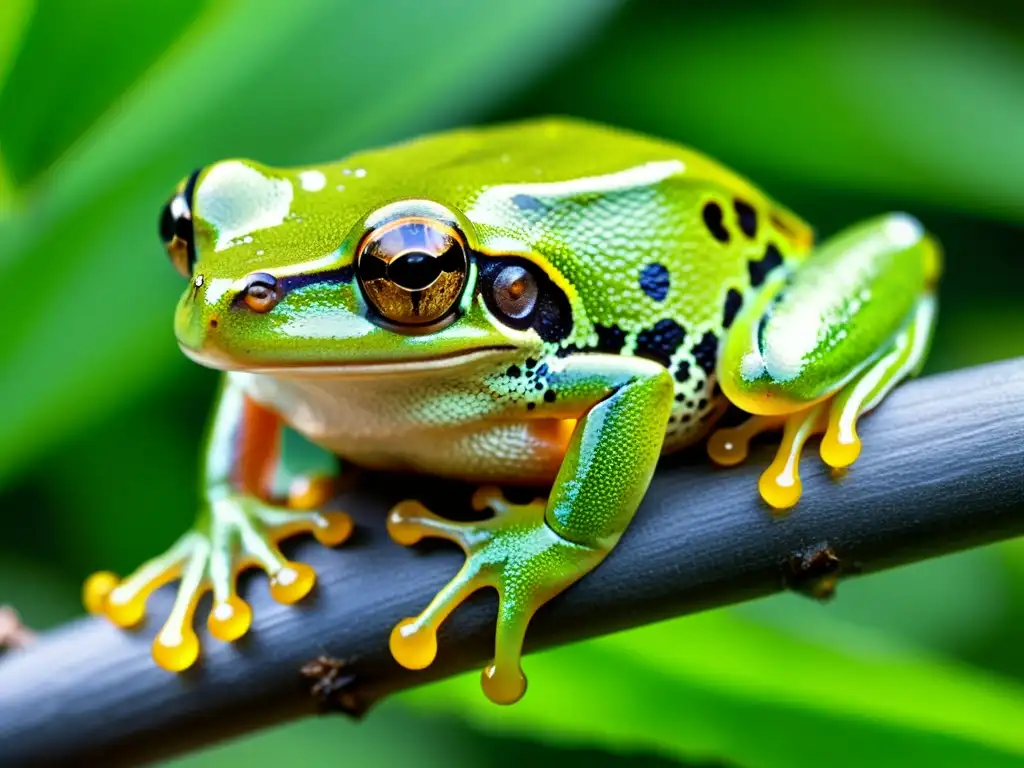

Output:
xmin=0 ymin=0 xmax=1024 ymax=768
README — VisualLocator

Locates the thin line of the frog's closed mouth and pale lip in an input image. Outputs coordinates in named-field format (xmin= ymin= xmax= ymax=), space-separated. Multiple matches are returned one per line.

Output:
xmin=179 ymin=345 xmax=516 ymax=378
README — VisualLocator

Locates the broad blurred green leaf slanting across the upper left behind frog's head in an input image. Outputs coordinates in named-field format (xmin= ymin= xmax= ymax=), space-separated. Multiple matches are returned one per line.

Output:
xmin=0 ymin=0 xmax=612 ymax=482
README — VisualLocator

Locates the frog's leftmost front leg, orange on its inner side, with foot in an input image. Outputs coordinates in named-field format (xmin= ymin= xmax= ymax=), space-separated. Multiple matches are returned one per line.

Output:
xmin=84 ymin=375 xmax=352 ymax=672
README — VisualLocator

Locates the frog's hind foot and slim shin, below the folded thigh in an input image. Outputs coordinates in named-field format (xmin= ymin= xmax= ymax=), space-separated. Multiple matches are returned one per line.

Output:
xmin=708 ymin=302 xmax=934 ymax=510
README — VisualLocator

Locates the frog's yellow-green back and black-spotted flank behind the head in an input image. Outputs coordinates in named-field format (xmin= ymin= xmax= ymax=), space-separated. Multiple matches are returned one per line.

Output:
xmin=335 ymin=119 xmax=812 ymax=447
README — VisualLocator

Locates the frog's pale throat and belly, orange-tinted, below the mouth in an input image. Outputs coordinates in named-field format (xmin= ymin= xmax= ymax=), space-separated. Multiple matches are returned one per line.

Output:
xmin=231 ymin=374 xmax=575 ymax=483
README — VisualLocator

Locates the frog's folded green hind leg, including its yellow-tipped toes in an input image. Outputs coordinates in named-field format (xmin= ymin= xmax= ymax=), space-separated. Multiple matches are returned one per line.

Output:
xmin=708 ymin=214 xmax=941 ymax=509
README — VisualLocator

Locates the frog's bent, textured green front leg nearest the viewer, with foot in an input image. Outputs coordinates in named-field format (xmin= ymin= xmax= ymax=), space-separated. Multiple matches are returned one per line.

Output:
xmin=388 ymin=355 xmax=673 ymax=703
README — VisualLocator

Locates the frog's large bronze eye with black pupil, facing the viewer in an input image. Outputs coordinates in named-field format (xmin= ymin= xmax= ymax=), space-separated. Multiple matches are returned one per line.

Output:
xmin=356 ymin=216 xmax=469 ymax=326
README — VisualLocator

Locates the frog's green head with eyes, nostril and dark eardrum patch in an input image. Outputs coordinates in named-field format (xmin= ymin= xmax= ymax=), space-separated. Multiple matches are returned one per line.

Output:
xmin=161 ymin=161 xmax=572 ymax=374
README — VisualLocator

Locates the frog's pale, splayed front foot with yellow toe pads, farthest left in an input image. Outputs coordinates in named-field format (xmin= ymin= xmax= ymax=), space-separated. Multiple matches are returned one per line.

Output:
xmin=84 ymin=496 xmax=352 ymax=672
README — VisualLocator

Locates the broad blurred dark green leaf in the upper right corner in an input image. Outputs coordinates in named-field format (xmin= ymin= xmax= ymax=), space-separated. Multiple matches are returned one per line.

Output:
xmin=512 ymin=3 xmax=1024 ymax=221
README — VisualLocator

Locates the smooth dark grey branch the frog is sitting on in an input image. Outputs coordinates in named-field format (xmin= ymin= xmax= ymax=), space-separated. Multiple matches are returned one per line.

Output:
xmin=0 ymin=359 xmax=1024 ymax=766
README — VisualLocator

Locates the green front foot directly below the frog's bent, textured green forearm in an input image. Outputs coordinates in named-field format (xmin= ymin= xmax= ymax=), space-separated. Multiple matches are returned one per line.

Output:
xmin=387 ymin=487 xmax=605 ymax=703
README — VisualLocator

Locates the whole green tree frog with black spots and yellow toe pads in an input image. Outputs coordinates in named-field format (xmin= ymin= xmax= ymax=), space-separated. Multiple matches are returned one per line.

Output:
xmin=84 ymin=118 xmax=942 ymax=703
